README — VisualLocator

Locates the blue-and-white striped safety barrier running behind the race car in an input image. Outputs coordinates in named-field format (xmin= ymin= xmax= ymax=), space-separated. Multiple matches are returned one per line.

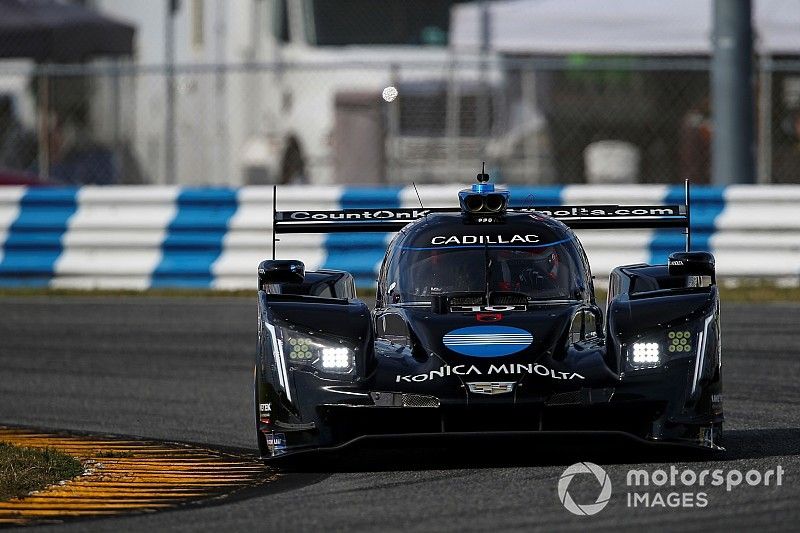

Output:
xmin=0 ymin=185 xmax=800 ymax=289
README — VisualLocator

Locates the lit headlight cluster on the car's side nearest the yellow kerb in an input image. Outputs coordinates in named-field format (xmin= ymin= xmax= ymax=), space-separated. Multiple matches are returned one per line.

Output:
xmin=283 ymin=329 xmax=355 ymax=374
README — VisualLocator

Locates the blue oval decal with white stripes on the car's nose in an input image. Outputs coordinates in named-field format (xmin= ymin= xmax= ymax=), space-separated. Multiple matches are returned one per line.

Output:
xmin=442 ymin=326 xmax=533 ymax=357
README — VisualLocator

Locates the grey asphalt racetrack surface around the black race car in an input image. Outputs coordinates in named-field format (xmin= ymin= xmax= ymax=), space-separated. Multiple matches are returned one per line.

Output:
xmin=0 ymin=296 xmax=800 ymax=531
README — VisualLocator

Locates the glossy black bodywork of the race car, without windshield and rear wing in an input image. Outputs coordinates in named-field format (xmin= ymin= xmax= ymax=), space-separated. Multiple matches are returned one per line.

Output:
xmin=254 ymin=208 xmax=723 ymax=459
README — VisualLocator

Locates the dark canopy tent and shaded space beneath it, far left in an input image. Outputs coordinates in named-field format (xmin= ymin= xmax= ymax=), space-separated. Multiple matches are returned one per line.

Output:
xmin=0 ymin=0 xmax=135 ymax=184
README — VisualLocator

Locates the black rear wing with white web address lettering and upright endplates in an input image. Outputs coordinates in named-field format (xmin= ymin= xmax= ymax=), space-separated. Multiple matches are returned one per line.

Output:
xmin=272 ymin=180 xmax=691 ymax=258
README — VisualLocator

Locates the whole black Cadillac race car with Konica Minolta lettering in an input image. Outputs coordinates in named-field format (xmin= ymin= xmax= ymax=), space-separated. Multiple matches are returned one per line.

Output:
xmin=254 ymin=174 xmax=723 ymax=460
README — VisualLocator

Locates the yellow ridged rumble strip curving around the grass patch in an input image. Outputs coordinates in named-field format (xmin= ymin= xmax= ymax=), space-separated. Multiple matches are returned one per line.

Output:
xmin=0 ymin=427 xmax=271 ymax=526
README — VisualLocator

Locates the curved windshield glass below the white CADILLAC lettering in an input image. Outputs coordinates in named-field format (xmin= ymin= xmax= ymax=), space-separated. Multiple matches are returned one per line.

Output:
xmin=385 ymin=239 xmax=584 ymax=303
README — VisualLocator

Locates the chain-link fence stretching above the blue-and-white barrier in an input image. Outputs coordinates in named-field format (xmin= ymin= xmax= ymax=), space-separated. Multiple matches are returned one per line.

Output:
xmin=0 ymin=57 xmax=800 ymax=186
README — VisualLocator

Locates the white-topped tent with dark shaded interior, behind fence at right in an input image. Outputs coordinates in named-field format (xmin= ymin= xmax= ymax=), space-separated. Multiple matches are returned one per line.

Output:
xmin=451 ymin=0 xmax=800 ymax=183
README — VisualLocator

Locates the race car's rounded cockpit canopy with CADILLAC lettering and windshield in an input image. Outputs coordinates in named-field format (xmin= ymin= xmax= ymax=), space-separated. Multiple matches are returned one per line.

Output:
xmin=378 ymin=214 xmax=589 ymax=304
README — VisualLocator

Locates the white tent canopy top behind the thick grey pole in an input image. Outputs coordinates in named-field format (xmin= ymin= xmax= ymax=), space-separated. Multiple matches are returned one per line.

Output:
xmin=450 ymin=0 xmax=800 ymax=55
